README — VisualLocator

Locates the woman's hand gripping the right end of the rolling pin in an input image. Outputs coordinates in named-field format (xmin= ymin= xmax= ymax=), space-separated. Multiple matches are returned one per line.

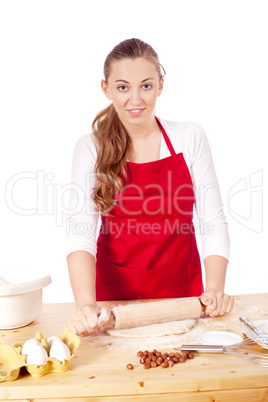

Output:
xmin=200 ymin=290 xmax=234 ymax=317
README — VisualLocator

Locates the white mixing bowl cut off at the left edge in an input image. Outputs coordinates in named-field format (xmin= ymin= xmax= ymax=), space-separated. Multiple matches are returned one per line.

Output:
xmin=0 ymin=267 xmax=51 ymax=330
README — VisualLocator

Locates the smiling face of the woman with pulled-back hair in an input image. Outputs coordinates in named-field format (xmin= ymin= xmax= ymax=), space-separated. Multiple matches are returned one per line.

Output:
xmin=101 ymin=57 xmax=164 ymax=126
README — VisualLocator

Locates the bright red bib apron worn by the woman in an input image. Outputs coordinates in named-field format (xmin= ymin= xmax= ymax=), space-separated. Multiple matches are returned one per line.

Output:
xmin=96 ymin=119 xmax=203 ymax=301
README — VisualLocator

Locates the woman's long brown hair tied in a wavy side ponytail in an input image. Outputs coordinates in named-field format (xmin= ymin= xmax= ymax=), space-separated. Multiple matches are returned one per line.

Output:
xmin=92 ymin=38 xmax=165 ymax=215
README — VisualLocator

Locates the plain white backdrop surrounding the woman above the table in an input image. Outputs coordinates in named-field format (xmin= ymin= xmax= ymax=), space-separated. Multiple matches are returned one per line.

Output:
xmin=0 ymin=0 xmax=268 ymax=302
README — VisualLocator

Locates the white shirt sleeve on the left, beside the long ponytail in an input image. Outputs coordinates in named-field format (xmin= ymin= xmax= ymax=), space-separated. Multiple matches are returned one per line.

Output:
xmin=66 ymin=134 xmax=99 ymax=258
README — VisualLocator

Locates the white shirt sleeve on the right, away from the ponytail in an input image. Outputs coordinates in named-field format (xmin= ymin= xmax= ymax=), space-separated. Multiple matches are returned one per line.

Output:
xmin=186 ymin=123 xmax=230 ymax=261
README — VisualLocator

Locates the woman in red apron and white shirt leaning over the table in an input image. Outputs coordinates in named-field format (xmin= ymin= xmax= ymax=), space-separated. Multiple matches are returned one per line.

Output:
xmin=67 ymin=39 xmax=233 ymax=335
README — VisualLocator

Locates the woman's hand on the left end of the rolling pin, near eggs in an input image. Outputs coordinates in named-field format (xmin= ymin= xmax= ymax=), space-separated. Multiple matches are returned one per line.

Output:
xmin=67 ymin=304 xmax=111 ymax=336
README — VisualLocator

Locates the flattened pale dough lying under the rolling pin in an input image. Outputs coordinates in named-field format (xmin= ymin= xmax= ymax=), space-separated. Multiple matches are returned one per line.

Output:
xmin=106 ymin=320 xmax=196 ymax=338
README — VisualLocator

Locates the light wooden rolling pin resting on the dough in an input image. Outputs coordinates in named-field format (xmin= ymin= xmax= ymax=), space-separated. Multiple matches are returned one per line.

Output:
xmin=105 ymin=297 xmax=206 ymax=329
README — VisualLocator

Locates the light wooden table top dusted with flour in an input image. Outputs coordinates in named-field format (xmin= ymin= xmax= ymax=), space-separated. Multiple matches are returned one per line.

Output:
xmin=0 ymin=294 xmax=268 ymax=402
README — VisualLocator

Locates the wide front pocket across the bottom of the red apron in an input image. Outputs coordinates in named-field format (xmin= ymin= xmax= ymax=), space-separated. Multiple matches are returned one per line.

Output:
xmin=96 ymin=260 xmax=190 ymax=301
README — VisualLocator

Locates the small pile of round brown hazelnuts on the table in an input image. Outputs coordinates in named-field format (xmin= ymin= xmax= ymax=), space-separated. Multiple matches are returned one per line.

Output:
xmin=126 ymin=349 xmax=194 ymax=370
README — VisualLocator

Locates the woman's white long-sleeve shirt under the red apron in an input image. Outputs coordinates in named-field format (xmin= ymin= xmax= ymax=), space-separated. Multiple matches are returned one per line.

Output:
xmin=66 ymin=119 xmax=230 ymax=260
